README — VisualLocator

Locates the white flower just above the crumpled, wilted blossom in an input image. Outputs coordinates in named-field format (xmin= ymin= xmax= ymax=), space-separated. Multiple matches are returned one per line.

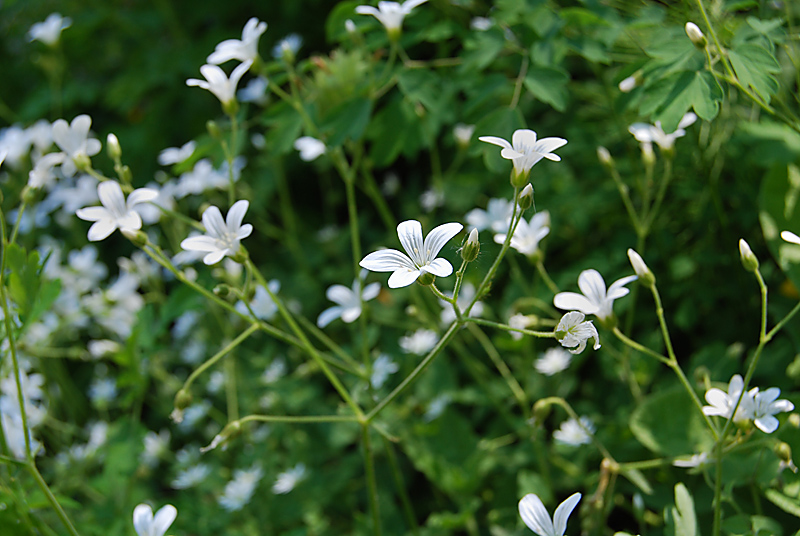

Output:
xmin=553 ymin=270 xmax=637 ymax=320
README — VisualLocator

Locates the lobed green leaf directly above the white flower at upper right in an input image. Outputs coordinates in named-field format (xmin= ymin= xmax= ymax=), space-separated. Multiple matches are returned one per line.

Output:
xmin=639 ymin=71 xmax=723 ymax=133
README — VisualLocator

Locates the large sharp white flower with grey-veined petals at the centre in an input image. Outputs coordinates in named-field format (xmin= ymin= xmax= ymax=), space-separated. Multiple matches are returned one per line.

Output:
xmin=359 ymin=220 xmax=463 ymax=288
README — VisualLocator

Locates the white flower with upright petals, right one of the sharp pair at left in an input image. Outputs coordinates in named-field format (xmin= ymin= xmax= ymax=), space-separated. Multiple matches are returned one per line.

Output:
xmin=181 ymin=200 xmax=253 ymax=265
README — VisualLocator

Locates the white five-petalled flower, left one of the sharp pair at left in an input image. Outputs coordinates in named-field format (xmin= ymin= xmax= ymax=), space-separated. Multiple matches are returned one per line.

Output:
xmin=75 ymin=181 xmax=158 ymax=242
